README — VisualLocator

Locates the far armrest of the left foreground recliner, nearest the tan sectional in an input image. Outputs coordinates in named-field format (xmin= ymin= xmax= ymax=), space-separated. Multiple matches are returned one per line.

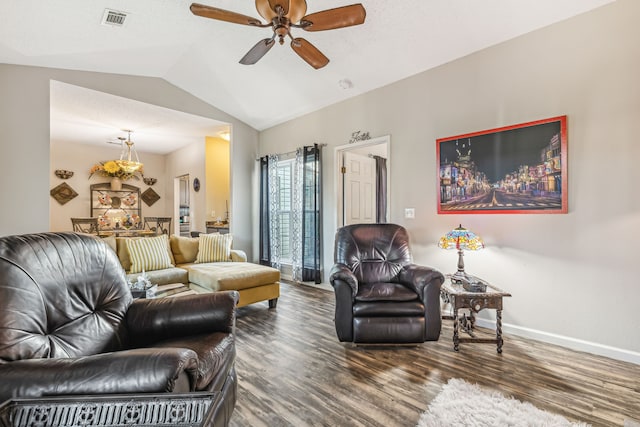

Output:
xmin=126 ymin=291 xmax=239 ymax=345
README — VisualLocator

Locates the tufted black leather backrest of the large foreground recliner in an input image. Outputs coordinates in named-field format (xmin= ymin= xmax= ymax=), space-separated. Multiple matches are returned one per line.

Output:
xmin=0 ymin=233 xmax=132 ymax=362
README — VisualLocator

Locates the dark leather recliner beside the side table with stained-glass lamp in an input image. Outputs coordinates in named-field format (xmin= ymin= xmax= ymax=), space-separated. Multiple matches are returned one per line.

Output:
xmin=329 ymin=224 xmax=444 ymax=344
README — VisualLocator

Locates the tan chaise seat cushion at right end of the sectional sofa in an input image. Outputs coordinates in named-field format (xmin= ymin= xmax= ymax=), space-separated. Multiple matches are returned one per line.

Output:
xmin=185 ymin=262 xmax=280 ymax=291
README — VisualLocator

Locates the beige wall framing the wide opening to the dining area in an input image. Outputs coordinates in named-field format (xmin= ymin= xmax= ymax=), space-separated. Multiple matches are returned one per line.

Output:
xmin=0 ymin=64 xmax=258 ymax=256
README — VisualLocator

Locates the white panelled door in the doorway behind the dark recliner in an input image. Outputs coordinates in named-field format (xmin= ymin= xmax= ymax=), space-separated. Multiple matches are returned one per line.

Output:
xmin=343 ymin=151 xmax=376 ymax=225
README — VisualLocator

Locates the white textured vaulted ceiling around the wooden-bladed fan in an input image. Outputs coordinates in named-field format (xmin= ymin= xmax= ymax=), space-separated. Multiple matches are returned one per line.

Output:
xmin=0 ymin=0 xmax=612 ymax=152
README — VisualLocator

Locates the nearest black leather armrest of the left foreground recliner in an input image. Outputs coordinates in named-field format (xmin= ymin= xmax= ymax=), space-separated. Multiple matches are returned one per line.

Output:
xmin=0 ymin=347 xmax=198 ymax=401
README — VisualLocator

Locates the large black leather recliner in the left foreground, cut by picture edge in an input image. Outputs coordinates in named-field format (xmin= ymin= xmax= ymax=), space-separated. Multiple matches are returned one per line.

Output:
xmin=0 ymin=233 xmax=238 ymax=425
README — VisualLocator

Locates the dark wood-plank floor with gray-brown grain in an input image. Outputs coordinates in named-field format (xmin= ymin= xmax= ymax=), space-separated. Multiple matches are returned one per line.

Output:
xmin=231 ymin=283 xmax=640 ymax=427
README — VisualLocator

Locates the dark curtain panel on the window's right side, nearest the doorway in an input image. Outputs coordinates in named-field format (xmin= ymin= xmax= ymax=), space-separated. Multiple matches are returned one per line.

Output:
xmin=302 ymin=144 xmax=322 ymax=283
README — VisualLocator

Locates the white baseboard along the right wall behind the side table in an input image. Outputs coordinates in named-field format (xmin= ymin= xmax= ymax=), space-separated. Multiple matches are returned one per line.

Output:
xmin=476 ymin=318 xmax=640 ymax=365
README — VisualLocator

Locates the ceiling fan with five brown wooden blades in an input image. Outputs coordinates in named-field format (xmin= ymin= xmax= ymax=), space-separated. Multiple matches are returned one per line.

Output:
xmin=190 ymin=0 xmax=366 ymax=69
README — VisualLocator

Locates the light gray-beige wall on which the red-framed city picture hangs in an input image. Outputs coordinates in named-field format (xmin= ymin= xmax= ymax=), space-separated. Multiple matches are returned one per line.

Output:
xmin=254 ymin=0 xmax=640 ymax=363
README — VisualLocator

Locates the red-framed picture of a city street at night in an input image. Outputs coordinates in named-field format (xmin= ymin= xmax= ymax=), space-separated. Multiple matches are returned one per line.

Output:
xmin=436 ymin=116 xmax=567 ymax=214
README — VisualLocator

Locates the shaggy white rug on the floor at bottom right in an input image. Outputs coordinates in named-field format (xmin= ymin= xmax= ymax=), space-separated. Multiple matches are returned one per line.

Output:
xmin=417 ymin=378 xmax=588 ymax=427
